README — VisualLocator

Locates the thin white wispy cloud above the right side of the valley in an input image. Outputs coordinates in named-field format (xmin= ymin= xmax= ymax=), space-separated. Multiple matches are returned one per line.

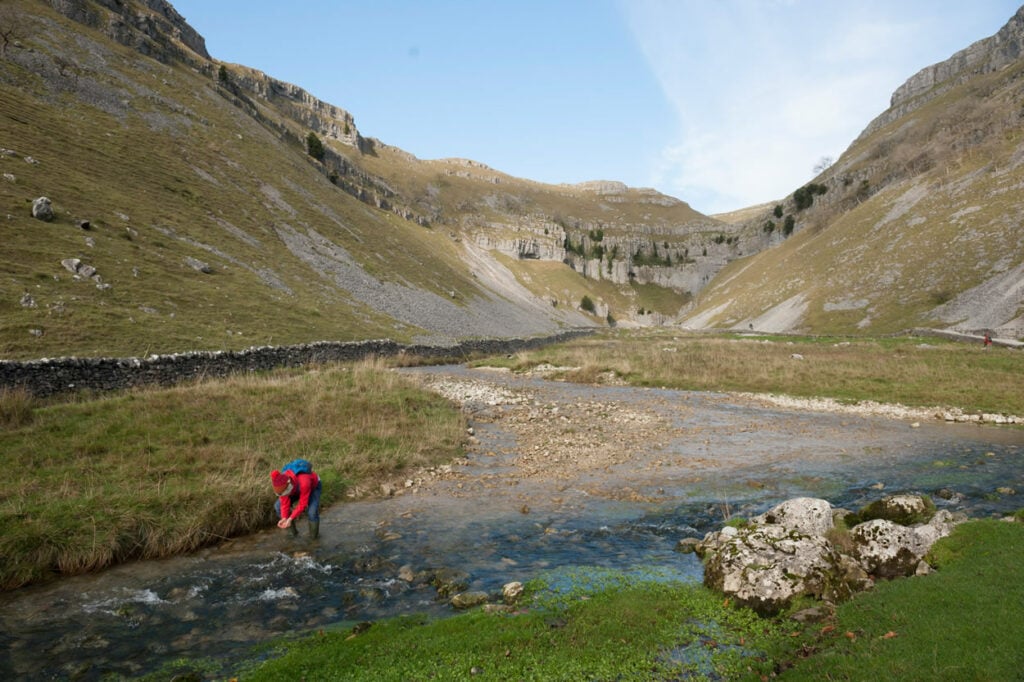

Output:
xmin=622 ymin=0 xmax=950 ymax=213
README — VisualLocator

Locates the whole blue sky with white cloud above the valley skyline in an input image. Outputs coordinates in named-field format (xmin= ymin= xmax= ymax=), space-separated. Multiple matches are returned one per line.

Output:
xmin=171 ymin=0 xmax=1019 ymax=214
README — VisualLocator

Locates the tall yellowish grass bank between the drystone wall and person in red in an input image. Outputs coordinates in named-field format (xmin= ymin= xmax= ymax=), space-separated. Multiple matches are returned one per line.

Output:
xmin=0 ymin=360 xmax=465 ymax=589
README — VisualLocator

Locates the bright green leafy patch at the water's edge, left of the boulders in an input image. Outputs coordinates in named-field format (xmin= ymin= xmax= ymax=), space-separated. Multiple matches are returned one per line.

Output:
xmin=242 ymin=583 xmax=777 ymax=682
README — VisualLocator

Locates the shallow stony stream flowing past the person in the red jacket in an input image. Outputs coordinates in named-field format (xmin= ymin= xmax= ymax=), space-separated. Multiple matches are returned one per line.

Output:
xmin=0 ymin=367 xmax=1024 ymax=680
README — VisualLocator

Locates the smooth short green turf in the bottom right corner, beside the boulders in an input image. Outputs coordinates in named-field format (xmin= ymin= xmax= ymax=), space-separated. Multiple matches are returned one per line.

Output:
xmin=779 ymin=520 xmax=1024 ymax=682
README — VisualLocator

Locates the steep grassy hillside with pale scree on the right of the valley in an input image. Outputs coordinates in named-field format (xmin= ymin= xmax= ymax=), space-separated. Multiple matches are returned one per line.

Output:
xmin=684 ymin=18 xmax=1024 ymax=337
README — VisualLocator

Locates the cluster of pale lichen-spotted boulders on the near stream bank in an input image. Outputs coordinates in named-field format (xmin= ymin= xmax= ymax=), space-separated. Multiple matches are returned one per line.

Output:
xmin=695 ymin=496 xmax=964 ymax=614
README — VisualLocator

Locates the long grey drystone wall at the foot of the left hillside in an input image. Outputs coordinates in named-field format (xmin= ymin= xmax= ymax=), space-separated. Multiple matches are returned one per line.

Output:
xmin=0 ymin=329 xmax=593 ymax=397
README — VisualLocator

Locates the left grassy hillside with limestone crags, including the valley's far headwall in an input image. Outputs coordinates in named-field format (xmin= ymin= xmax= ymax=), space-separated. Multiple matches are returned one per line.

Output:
xmin=0 ymin=0 xmax=717 ymax=358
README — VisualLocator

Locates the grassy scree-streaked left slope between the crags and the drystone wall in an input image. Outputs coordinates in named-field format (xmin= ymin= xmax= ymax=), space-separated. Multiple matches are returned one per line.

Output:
xmin=0 ymin=3 xmax=507 ymax=357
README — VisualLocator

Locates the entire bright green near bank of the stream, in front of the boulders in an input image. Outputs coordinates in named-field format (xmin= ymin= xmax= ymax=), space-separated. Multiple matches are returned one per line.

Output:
xmin=234 ymin=520 xmax=1024 ymax=681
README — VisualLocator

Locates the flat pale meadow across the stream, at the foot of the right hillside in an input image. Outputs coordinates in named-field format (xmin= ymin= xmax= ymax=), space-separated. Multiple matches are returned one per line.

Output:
xmin=477 ymin=330 xmax=1024 ymax=415
